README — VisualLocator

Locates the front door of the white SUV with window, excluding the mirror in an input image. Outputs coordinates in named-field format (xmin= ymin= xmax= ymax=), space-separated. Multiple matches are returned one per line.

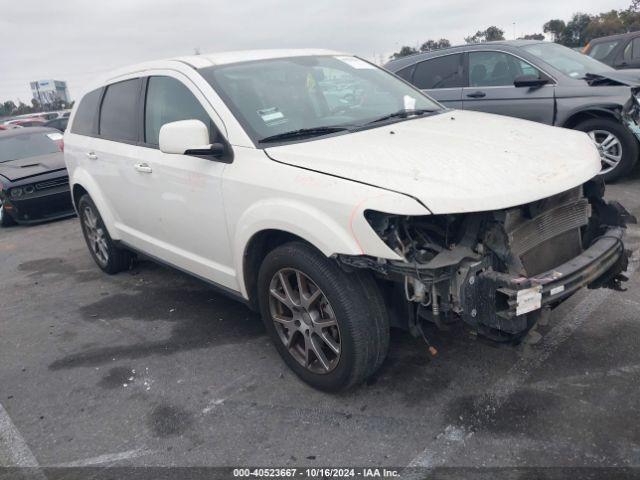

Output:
xmin=120 ymin=71 xmax=236 ymax=288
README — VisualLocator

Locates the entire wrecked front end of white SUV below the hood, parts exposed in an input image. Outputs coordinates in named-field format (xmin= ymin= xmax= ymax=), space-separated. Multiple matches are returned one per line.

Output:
xmin=337 ymin=179 xmax=635 ymax=341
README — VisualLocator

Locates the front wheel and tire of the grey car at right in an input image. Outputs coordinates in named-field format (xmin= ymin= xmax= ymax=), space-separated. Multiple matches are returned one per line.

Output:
xmin=575 ymin=118 xmax=638 ymax=182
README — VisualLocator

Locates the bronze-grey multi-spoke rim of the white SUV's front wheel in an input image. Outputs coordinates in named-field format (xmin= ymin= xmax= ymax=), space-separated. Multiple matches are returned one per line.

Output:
xmin=269 ymin=268 xmax=341 ymax=374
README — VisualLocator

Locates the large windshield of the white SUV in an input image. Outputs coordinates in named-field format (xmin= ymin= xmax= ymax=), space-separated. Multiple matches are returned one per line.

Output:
xmin=200 ymin=56 xmax=443 ymax=143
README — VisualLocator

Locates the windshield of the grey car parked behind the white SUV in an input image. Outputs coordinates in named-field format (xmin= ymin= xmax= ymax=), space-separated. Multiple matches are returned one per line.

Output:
xmin=522 ymin=42 xmax=613 ymax=78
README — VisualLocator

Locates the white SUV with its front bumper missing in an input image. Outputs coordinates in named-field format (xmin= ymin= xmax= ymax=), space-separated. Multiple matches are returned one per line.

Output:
xmin=64 ymin=50 xmax=631 ymax=391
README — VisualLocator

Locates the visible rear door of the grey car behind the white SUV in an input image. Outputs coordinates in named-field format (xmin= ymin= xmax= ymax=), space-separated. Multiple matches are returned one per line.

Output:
xmin=398 ymin=53 xmax=464 ymax=108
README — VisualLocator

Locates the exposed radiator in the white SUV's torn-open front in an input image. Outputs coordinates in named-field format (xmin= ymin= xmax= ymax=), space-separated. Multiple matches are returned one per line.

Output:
xmin=505 ymin=187 xmax=591 ymax=276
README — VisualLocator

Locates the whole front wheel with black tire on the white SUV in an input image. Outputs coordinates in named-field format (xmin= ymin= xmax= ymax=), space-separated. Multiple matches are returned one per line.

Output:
xmin=258 ymin=242 xmax=389 ymax=392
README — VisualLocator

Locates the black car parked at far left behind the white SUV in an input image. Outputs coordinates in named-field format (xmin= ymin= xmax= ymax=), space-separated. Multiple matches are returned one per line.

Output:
xmin=0 ymin=127 xmax=75 ymax=227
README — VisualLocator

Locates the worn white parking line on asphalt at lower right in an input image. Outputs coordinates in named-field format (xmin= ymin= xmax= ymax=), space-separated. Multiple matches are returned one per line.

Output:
xmin=407 ymin=262 xmax=635 ymax=468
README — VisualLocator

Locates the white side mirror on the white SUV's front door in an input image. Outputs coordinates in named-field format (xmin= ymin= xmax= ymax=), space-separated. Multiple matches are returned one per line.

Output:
xmin=160 ymin=120 xmax=224 ymax=157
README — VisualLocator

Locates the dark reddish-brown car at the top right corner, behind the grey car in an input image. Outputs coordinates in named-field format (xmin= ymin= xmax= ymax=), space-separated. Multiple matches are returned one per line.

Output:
xmin=582 ymin=32 xmax=640 ymax=69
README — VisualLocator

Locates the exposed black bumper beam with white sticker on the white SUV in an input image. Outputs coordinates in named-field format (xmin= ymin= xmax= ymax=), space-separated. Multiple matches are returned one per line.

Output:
xmin=461 ymin=227 xmax=629 ymax=335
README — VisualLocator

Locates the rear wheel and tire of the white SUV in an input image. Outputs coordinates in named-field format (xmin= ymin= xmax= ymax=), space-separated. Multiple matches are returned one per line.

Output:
xmin=78 ymin=194 xmax=133 ymax=275
